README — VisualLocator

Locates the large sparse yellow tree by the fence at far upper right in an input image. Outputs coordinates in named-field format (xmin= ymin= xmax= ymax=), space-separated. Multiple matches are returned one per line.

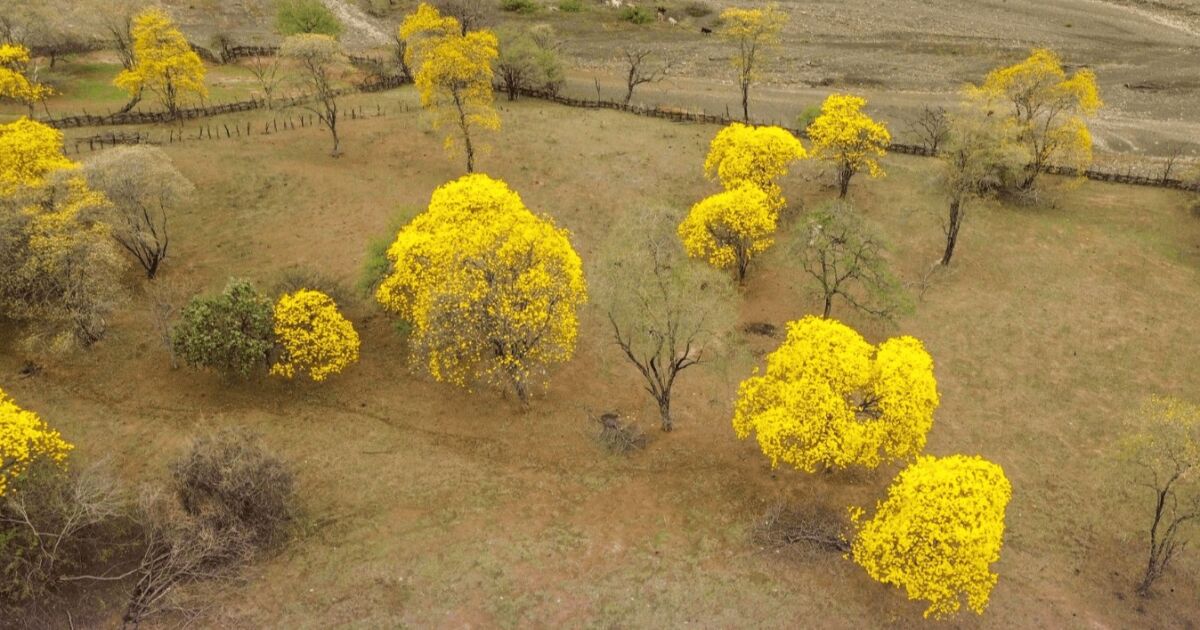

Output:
xmin=967 ymin=48 xmax=1104 ymax=190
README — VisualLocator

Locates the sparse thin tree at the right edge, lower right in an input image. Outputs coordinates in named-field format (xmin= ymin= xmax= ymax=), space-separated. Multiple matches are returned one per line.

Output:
xmin=1120 ymin=397 xmax=1200 ymax=596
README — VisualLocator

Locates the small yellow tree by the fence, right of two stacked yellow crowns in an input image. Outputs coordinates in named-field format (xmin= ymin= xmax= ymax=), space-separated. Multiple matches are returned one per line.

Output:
xmin=808 ymin=94 xmax=892 ymax=198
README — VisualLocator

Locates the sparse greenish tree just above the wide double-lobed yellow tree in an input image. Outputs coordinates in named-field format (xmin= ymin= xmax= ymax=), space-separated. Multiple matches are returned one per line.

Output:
xmin=796 ymin=202 xmax=911 ymax=320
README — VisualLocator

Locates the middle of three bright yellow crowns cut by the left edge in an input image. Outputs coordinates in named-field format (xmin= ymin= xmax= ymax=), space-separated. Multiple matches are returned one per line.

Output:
xmin=0 ymin=118 xmax=77 ymax=194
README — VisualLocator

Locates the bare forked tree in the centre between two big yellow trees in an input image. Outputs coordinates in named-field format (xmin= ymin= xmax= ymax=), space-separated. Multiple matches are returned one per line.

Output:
xmin=599 ymin=206 xmax=737 ymax=431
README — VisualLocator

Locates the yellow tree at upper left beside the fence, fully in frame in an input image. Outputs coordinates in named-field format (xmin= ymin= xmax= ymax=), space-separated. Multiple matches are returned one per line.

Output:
xmin=113 ymin=7 xmax=208 ymax=115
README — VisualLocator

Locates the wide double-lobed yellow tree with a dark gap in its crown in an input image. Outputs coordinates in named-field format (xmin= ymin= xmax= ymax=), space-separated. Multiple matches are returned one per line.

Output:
xmin=733 ymin=316 xmax=938 ymax=473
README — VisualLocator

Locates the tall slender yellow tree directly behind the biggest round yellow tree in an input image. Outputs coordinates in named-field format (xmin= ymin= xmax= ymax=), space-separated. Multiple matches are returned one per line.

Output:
xmin=400 ymin=4 xmax=500 ymax=173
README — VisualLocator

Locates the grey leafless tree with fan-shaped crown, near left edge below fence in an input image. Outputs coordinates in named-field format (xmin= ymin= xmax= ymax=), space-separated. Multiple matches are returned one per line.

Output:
xmin=85 ymin=145 xmax=194 ymax=278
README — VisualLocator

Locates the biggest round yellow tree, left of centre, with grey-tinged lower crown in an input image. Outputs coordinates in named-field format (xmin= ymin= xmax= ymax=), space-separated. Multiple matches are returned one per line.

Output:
xmin=376 ymin=175 xmax=587 ymax=401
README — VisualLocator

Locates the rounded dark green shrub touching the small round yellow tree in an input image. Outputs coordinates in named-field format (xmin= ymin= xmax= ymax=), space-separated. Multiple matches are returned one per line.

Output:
xmin=170 ymin=280 xmax=275 ymax=377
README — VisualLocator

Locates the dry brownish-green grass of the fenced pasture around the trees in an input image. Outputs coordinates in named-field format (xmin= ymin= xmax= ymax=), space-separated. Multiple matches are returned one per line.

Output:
xmin=0 ymin=78 xmax=1200 ymax=628
